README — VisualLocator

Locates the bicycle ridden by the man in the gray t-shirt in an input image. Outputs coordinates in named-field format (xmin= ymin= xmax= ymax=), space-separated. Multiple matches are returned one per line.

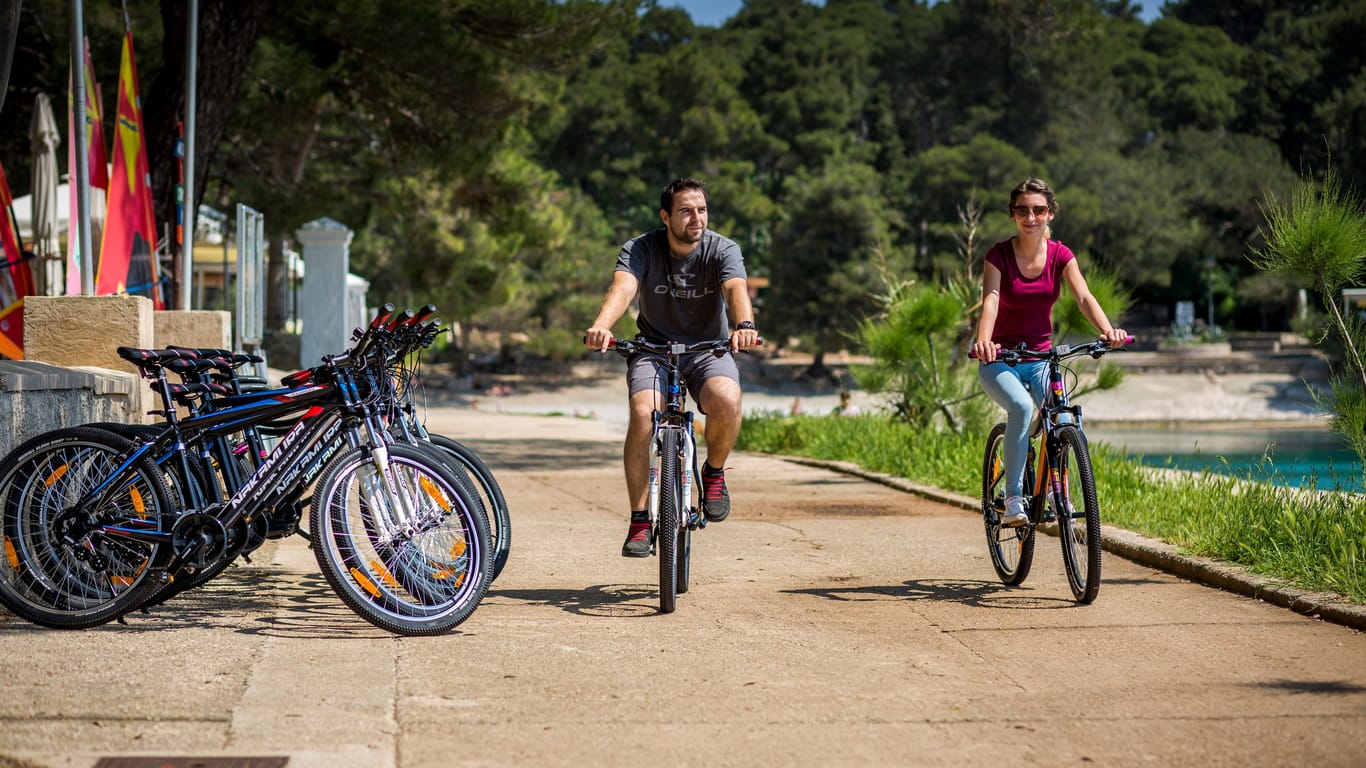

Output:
xmin=608 ymin=339 xmax=762 ymax=614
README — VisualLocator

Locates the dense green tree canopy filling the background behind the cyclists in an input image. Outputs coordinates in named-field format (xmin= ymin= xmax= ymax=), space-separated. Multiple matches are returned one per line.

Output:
xmin=0 ymin=0 xmax=1366 ymax=360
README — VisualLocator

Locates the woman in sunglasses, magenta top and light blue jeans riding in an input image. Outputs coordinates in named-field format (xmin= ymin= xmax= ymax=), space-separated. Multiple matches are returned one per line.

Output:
xmin=973 ymin=178 xmax=1128 ymax=526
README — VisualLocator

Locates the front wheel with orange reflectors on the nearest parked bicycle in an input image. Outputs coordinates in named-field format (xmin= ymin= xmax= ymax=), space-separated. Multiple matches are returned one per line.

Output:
xmin=309 ymin=444 xmax=492 ymax=635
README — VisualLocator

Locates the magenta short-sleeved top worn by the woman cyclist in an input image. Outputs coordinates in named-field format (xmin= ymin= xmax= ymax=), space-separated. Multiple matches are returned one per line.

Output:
xmin=986 ymin=241 xmax=1076 ymax=350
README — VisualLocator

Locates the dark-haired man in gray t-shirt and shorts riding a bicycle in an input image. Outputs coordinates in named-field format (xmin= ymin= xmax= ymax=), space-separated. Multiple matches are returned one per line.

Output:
xmin=585 ymin=179 xmax=758 ymax=558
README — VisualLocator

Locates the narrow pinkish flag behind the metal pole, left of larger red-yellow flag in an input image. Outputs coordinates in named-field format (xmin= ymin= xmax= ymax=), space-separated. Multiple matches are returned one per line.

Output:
xmin=67 ymin=40 xmax=109 ymax=295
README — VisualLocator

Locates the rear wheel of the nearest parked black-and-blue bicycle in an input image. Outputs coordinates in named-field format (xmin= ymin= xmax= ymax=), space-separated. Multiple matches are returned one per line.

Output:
xmin=0 ymin=426 xmax=173 ymax=629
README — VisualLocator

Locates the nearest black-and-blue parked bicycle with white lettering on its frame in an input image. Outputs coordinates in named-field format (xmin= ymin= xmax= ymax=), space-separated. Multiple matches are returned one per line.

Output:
xmin=0 ymin=302 xmax=490 ymax=634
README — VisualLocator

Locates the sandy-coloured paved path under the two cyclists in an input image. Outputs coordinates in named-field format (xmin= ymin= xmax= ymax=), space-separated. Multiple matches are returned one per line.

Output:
xmin=0 ymin=410 xmax=1366 ymax=768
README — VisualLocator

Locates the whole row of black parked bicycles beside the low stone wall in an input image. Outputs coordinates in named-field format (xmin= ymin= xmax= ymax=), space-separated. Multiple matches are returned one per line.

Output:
xmin=0 ymin=305 xmax=511 ymax=635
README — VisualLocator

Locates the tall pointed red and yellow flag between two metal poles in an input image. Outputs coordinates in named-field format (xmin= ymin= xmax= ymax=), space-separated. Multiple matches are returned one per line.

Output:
xmin=94 ymin=30 xmax=163 ymax=309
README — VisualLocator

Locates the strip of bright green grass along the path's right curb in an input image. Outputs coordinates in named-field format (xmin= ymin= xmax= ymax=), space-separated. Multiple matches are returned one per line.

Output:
xmin=736 ymin=414 xmax=1366 ymax=603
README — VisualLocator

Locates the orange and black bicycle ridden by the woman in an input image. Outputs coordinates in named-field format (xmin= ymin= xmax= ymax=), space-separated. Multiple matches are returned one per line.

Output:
xmin=982 ymin=338 xmax=1132 ymax=603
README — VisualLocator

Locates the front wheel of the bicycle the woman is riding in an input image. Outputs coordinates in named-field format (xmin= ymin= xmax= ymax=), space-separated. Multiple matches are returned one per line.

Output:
xmin=1052 ymin=426 xmax=1101 ymax=603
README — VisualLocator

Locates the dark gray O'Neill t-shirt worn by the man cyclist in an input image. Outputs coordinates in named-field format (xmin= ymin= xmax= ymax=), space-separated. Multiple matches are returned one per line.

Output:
xmin=616 ymin=227 xmax=746 ymax=343
